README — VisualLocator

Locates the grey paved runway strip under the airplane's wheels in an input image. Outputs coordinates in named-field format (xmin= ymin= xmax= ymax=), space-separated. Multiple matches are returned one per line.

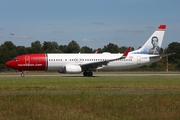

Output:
xmin=0 ymin=73 xmax=180 ymax=78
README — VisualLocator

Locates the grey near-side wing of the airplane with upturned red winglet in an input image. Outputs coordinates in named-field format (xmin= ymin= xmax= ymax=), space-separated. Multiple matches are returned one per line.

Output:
xmin=80 ymin=47 xmax=131 ymax=70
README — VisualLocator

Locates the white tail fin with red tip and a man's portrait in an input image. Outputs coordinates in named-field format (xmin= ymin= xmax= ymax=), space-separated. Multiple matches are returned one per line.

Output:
xmin=131 ymin=25 xmax=166 ymax=55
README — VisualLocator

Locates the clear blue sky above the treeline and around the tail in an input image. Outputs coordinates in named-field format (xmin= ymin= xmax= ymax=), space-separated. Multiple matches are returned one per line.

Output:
xmin=0 ymin=0 xmax=180 ymax=49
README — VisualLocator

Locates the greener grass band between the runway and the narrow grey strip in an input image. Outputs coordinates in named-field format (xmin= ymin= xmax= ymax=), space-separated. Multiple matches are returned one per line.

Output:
xmin=0 ymin=76 xmax=180 ymax=91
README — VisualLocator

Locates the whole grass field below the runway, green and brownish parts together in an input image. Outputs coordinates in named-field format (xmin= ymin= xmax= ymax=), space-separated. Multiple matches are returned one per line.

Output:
xmin=0 ymin=76 xmax=180 ymax=120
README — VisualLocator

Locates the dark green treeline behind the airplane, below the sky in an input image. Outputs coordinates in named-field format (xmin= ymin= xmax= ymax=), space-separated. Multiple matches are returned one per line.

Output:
xmin=0 ymin=40 xmax=180 ymax=71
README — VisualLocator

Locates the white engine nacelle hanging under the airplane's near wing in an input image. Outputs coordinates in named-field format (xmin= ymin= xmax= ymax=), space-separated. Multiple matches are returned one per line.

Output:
xmin=59 ymin=65 xmax=82 ymax=73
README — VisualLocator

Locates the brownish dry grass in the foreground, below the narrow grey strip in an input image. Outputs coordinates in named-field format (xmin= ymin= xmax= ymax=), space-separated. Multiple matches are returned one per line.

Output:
xmin=0 ymin=93 xmax=180 ymax=120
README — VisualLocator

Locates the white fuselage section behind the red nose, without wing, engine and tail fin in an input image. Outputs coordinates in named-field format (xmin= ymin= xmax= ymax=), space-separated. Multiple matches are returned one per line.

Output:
xmin=47 ymin=53 xmax=160 ymax=70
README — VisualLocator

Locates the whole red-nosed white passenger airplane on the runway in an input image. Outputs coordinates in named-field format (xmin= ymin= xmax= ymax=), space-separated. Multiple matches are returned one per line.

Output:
xmin=6 ymin=24 xmax=166 ymax=77
